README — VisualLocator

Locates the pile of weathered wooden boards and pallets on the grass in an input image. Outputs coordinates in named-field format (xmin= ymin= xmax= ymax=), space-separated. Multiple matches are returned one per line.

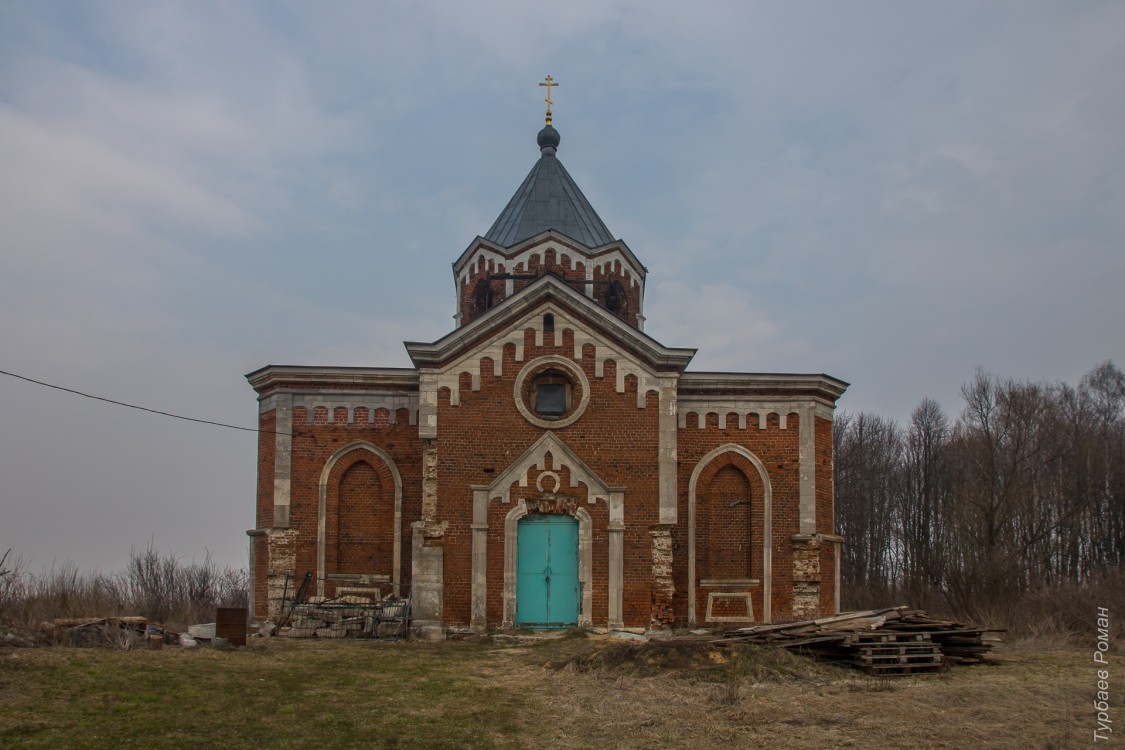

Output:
xmin=723 ymin=606 xmax=992 ymax=675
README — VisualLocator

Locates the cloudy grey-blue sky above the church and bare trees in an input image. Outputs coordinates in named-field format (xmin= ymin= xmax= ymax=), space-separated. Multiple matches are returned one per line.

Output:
xmin=0 ymin=0 xmax=1125 ymax=570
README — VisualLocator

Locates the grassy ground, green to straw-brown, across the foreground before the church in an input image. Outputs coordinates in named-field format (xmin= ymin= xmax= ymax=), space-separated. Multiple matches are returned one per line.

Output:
xmin=0 ymin=639 xmax=1118 ymax=750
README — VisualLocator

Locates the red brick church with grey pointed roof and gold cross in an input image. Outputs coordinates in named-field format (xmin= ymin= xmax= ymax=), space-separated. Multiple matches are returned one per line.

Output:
xmin=246 ymin=89 xmax=847 ymax=638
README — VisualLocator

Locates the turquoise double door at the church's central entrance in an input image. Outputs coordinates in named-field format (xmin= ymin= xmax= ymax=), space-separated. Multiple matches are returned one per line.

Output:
xmin=515 ymin=515 xmax=578 ymax=627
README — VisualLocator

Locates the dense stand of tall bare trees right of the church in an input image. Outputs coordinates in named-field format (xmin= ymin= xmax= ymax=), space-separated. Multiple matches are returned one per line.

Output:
xmin=834 ymin=362 xmax=1125 ymax=614
